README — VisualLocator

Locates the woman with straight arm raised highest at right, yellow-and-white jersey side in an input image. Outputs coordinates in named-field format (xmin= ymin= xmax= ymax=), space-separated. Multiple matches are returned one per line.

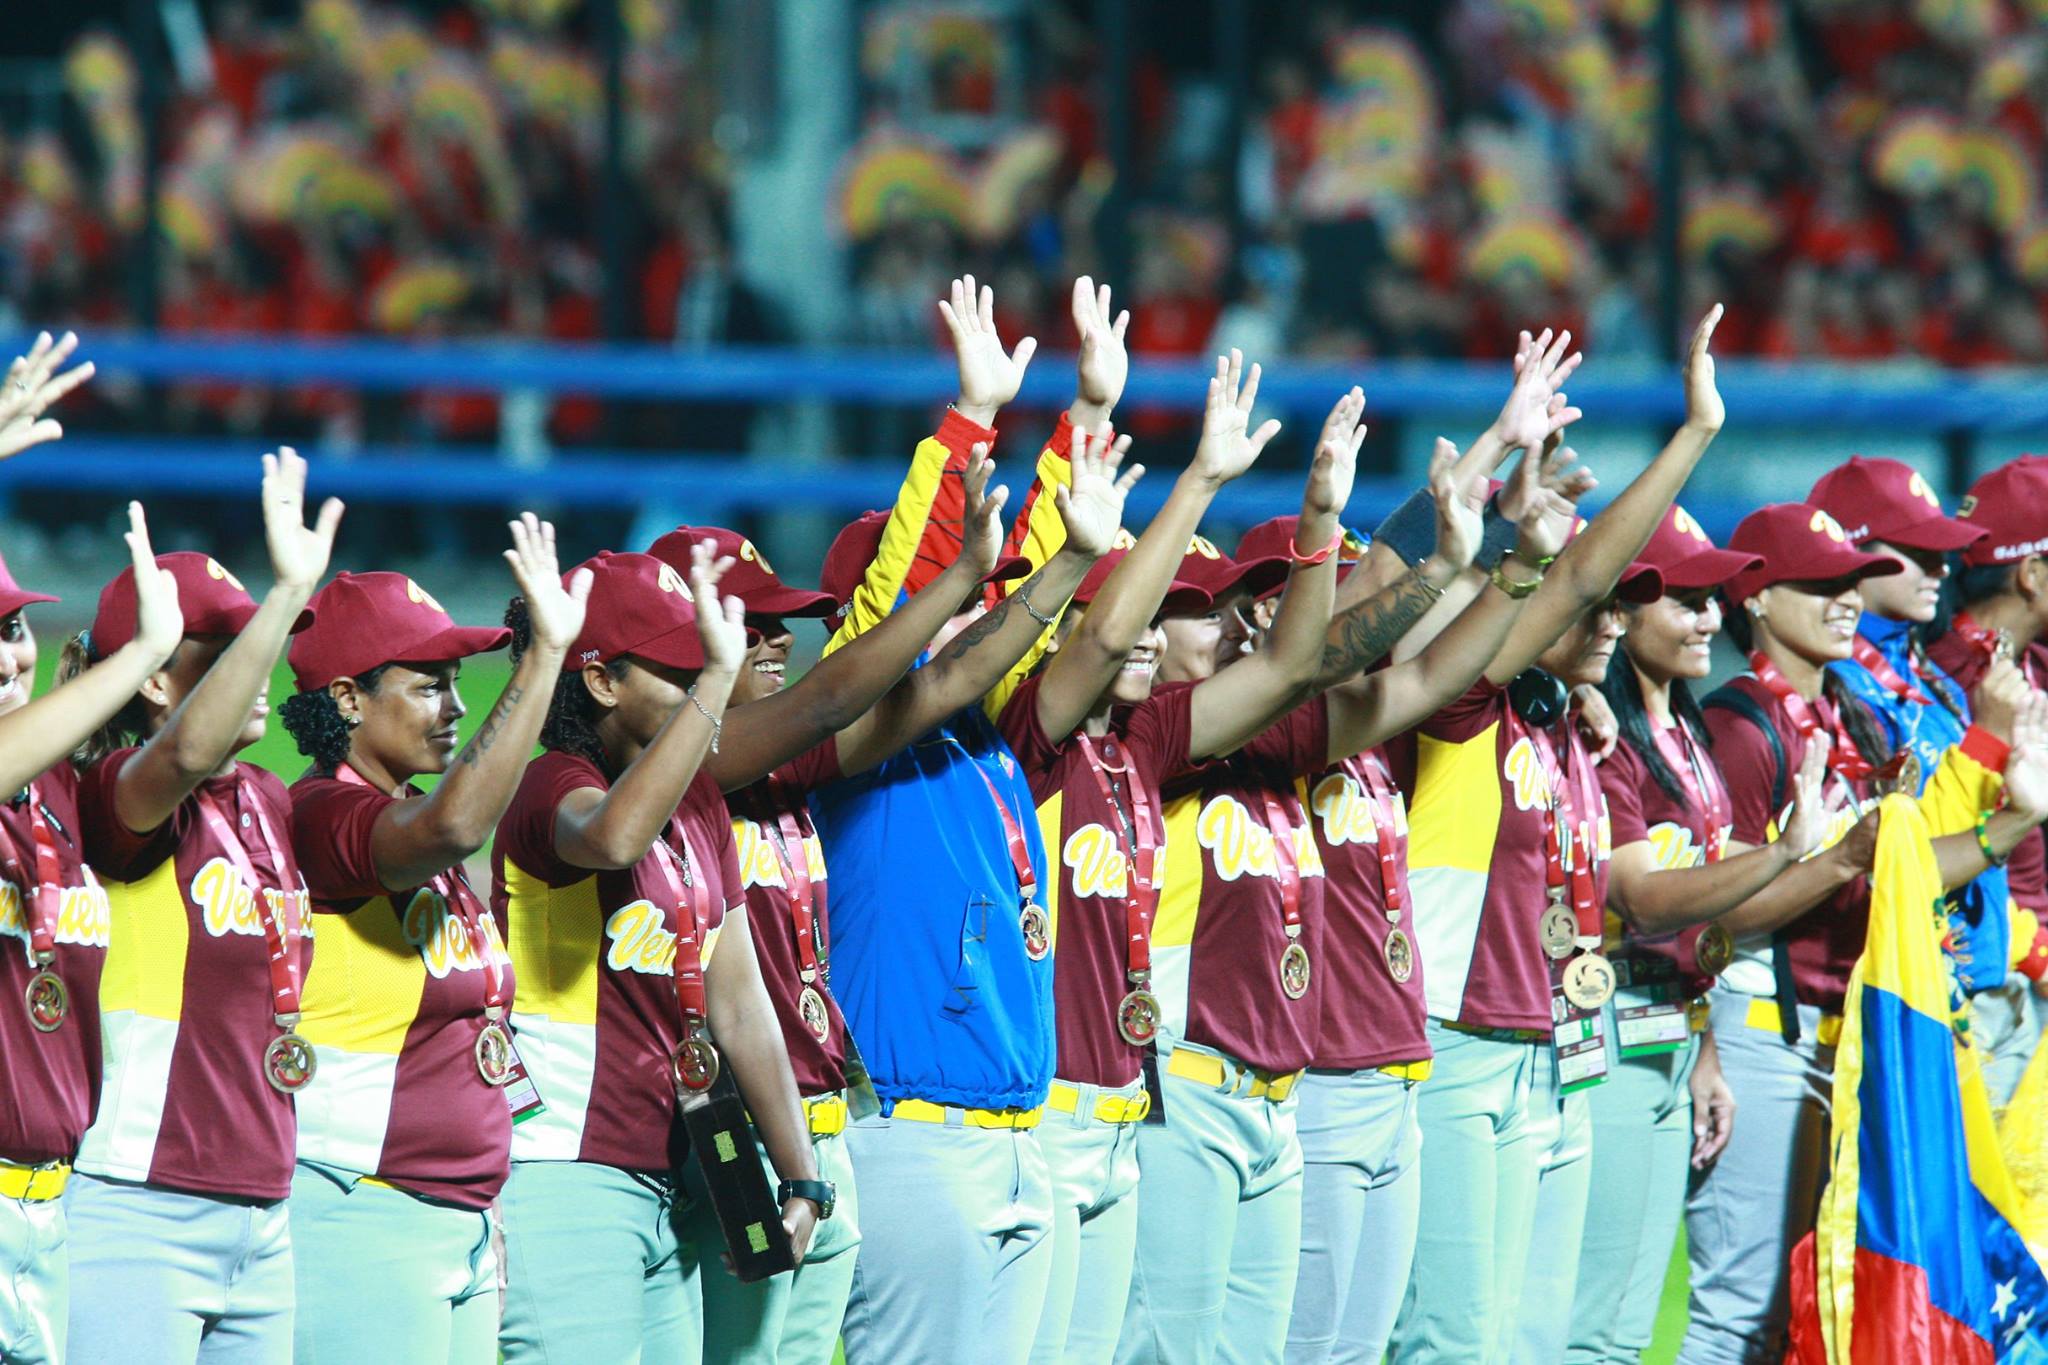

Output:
xmin=1395 ymin=307 xmax=1724 ymax=1363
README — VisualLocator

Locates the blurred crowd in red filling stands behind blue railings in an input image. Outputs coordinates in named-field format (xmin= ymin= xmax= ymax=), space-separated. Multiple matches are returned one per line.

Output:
xmin=0 ymin=0 xmax=2048 ymax=454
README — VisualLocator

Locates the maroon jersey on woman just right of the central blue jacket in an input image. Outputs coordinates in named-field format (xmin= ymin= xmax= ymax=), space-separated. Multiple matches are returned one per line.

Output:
xmin=999 ymin=675 xmax=1194 ymax=1087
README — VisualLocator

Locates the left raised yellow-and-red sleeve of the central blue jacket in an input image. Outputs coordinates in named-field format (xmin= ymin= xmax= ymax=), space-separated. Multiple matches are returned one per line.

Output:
xmin=825 ymin=407 xmax=995 ymax=655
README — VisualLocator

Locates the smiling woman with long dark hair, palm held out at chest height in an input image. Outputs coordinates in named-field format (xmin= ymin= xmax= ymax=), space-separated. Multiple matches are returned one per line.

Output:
xmin=1565 ymin=505 xmax=1827 ymax=1363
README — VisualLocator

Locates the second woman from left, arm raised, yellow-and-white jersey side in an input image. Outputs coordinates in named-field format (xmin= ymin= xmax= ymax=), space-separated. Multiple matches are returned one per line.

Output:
xmin=61 ymin=448 xmax=342 ymax=1361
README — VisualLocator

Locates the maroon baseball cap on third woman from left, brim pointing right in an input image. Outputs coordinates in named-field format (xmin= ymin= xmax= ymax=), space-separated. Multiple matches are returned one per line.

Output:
xmin=285 ymin=573 xmax=512 ymax=692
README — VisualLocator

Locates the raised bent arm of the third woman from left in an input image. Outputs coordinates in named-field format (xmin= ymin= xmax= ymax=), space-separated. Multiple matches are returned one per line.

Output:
xmin=371 ymin=512 xmax=590 ymax=888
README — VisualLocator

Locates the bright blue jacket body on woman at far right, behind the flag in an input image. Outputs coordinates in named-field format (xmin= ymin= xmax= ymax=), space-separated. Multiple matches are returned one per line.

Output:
xmin=1827 ymin=612 xmax=2011 ymax=995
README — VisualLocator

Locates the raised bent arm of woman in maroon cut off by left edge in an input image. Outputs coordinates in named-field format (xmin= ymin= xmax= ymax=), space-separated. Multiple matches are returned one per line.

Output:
xmin=0 ymin=501 xmax=184 ymax=794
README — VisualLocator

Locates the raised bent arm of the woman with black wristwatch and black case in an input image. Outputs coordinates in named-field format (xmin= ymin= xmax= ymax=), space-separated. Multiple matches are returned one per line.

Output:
xmin=555 ymin=540 xmax=748 ymax=870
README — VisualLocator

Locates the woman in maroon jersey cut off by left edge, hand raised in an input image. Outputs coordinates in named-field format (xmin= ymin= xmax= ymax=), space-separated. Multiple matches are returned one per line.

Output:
xmin=0 ymin=503 xmax=184 ymax=1365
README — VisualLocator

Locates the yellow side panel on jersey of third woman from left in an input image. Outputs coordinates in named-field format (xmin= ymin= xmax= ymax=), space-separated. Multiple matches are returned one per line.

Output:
xmin=299 ymin=890 xmax=432 ymax=1056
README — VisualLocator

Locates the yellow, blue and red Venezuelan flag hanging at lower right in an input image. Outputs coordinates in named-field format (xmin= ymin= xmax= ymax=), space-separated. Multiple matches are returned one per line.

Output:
xmin=1786 ymin=796 xmax=2048 ymax=1365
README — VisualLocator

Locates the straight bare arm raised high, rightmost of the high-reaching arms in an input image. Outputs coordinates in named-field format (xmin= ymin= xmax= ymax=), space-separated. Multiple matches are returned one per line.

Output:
xmin=1487 ymin=303 xmax=1726 ymax=686
